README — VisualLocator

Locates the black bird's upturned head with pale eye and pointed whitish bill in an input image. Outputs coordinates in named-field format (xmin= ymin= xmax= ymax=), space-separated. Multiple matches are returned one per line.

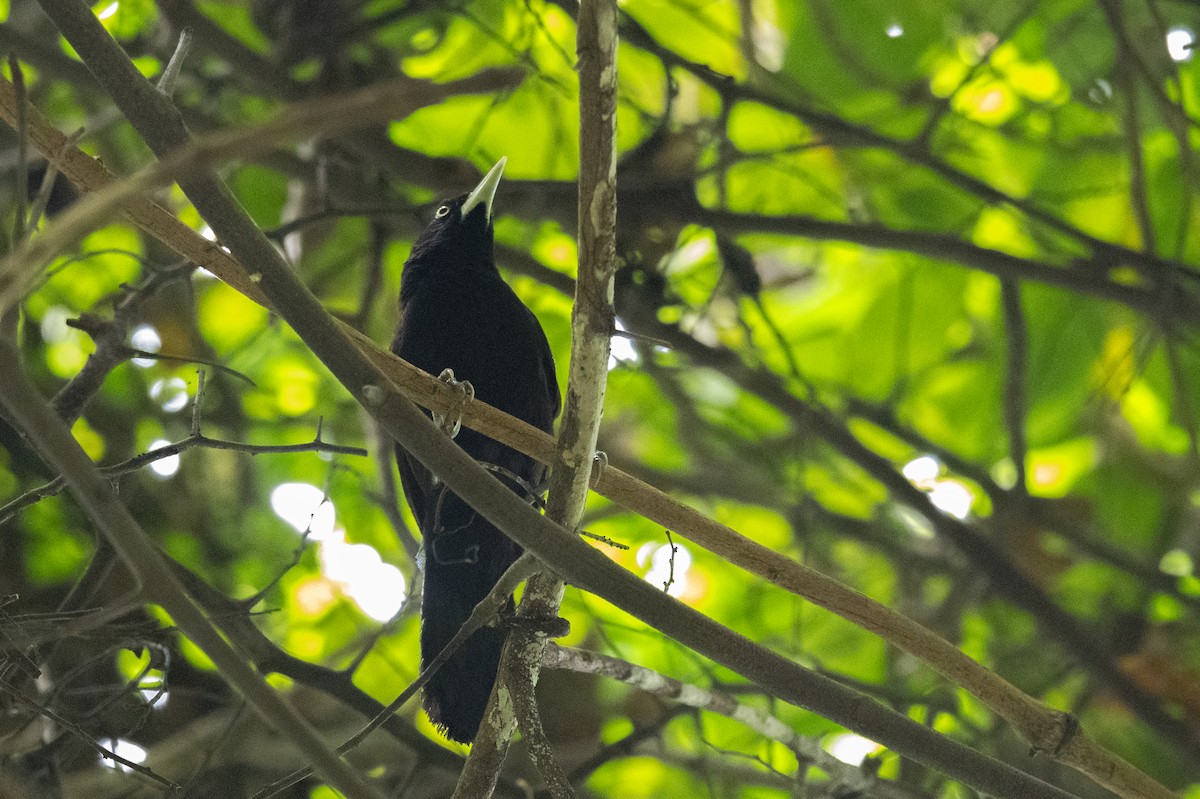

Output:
xmin=407 ymin=158 xmax=508 ymax=271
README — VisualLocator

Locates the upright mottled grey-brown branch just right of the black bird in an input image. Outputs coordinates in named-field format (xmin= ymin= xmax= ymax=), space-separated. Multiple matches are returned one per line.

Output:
xmin=455 ymin=0 xmax=617 ymax=798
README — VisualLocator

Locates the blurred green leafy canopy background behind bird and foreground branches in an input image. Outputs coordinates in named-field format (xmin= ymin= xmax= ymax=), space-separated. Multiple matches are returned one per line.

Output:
xmin=0 ymin=0 xmax=1200 ymax=799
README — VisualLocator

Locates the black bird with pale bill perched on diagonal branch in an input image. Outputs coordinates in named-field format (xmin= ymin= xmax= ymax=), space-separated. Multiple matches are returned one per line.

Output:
xmin=391 ymin=158 xmax=562 ymax=744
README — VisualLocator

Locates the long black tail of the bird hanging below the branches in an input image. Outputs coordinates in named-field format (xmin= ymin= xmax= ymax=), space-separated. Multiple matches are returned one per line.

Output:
xmin=421 ymin=489 xmax=520 ymax=744
